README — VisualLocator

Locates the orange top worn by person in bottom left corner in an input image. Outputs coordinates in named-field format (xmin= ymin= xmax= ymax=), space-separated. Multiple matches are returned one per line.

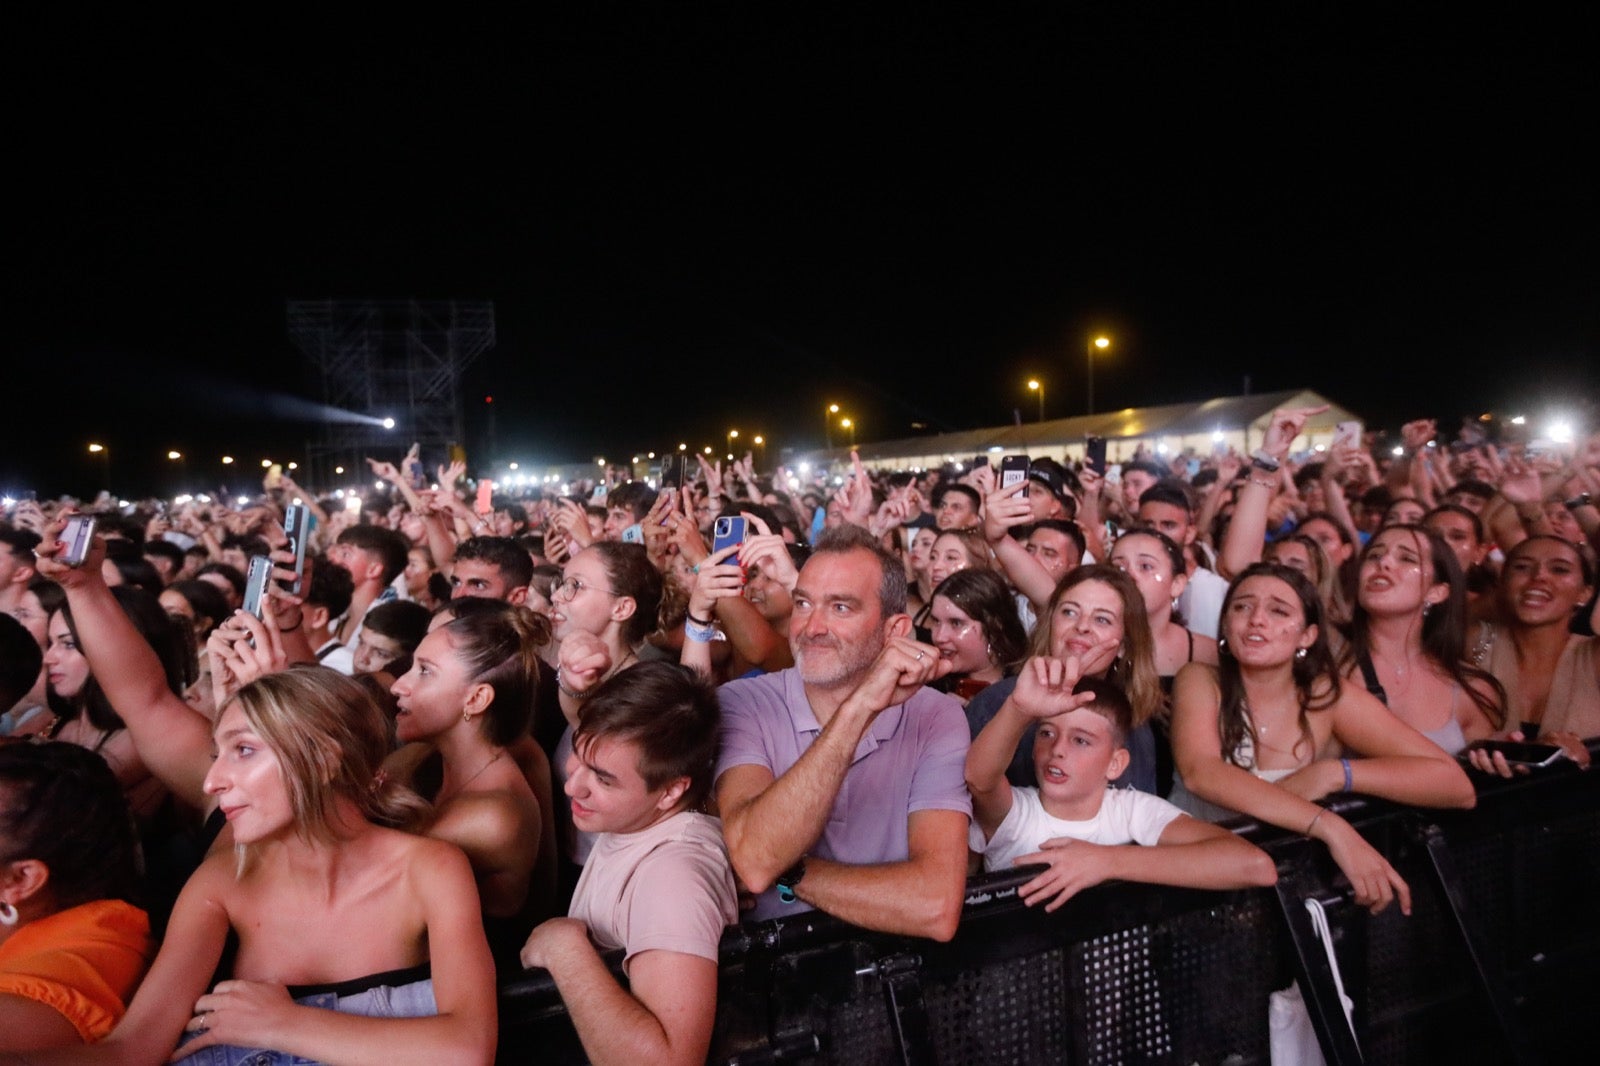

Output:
xmin=0 ymin=900 xmax=152 ymax=1044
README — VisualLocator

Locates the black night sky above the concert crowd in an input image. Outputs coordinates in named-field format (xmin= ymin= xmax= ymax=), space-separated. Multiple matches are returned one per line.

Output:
xmin=0 ymin=3 xmax=1600 ymax=495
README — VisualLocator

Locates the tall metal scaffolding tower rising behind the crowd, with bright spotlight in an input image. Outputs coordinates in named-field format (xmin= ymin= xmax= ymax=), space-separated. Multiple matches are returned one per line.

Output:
xmin=288 ymin=299 xmax=494 ymax=485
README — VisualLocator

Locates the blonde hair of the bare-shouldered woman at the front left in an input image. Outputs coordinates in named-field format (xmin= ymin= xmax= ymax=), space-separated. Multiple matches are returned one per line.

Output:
xmin=234 ymin=664 xmax=430 ymax=872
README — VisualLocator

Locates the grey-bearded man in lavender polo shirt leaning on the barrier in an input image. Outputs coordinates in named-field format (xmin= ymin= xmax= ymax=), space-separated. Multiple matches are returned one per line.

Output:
xmin=717 ymin=525 xmax=973 ymax=940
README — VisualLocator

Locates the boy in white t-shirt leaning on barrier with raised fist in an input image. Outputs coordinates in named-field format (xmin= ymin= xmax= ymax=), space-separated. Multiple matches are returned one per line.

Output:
xmin=966 ymin=658 xmax=1277 ymax=911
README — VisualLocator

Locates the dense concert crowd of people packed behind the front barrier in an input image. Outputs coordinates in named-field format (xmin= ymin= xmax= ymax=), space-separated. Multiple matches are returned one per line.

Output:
xmin=0 ymin=410 xmax=1600 ymax=1066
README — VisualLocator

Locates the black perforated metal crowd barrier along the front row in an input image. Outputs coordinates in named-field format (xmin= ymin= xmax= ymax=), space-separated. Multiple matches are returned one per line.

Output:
xmin=501 ymin=745 xmax=1600 ymax=1066
